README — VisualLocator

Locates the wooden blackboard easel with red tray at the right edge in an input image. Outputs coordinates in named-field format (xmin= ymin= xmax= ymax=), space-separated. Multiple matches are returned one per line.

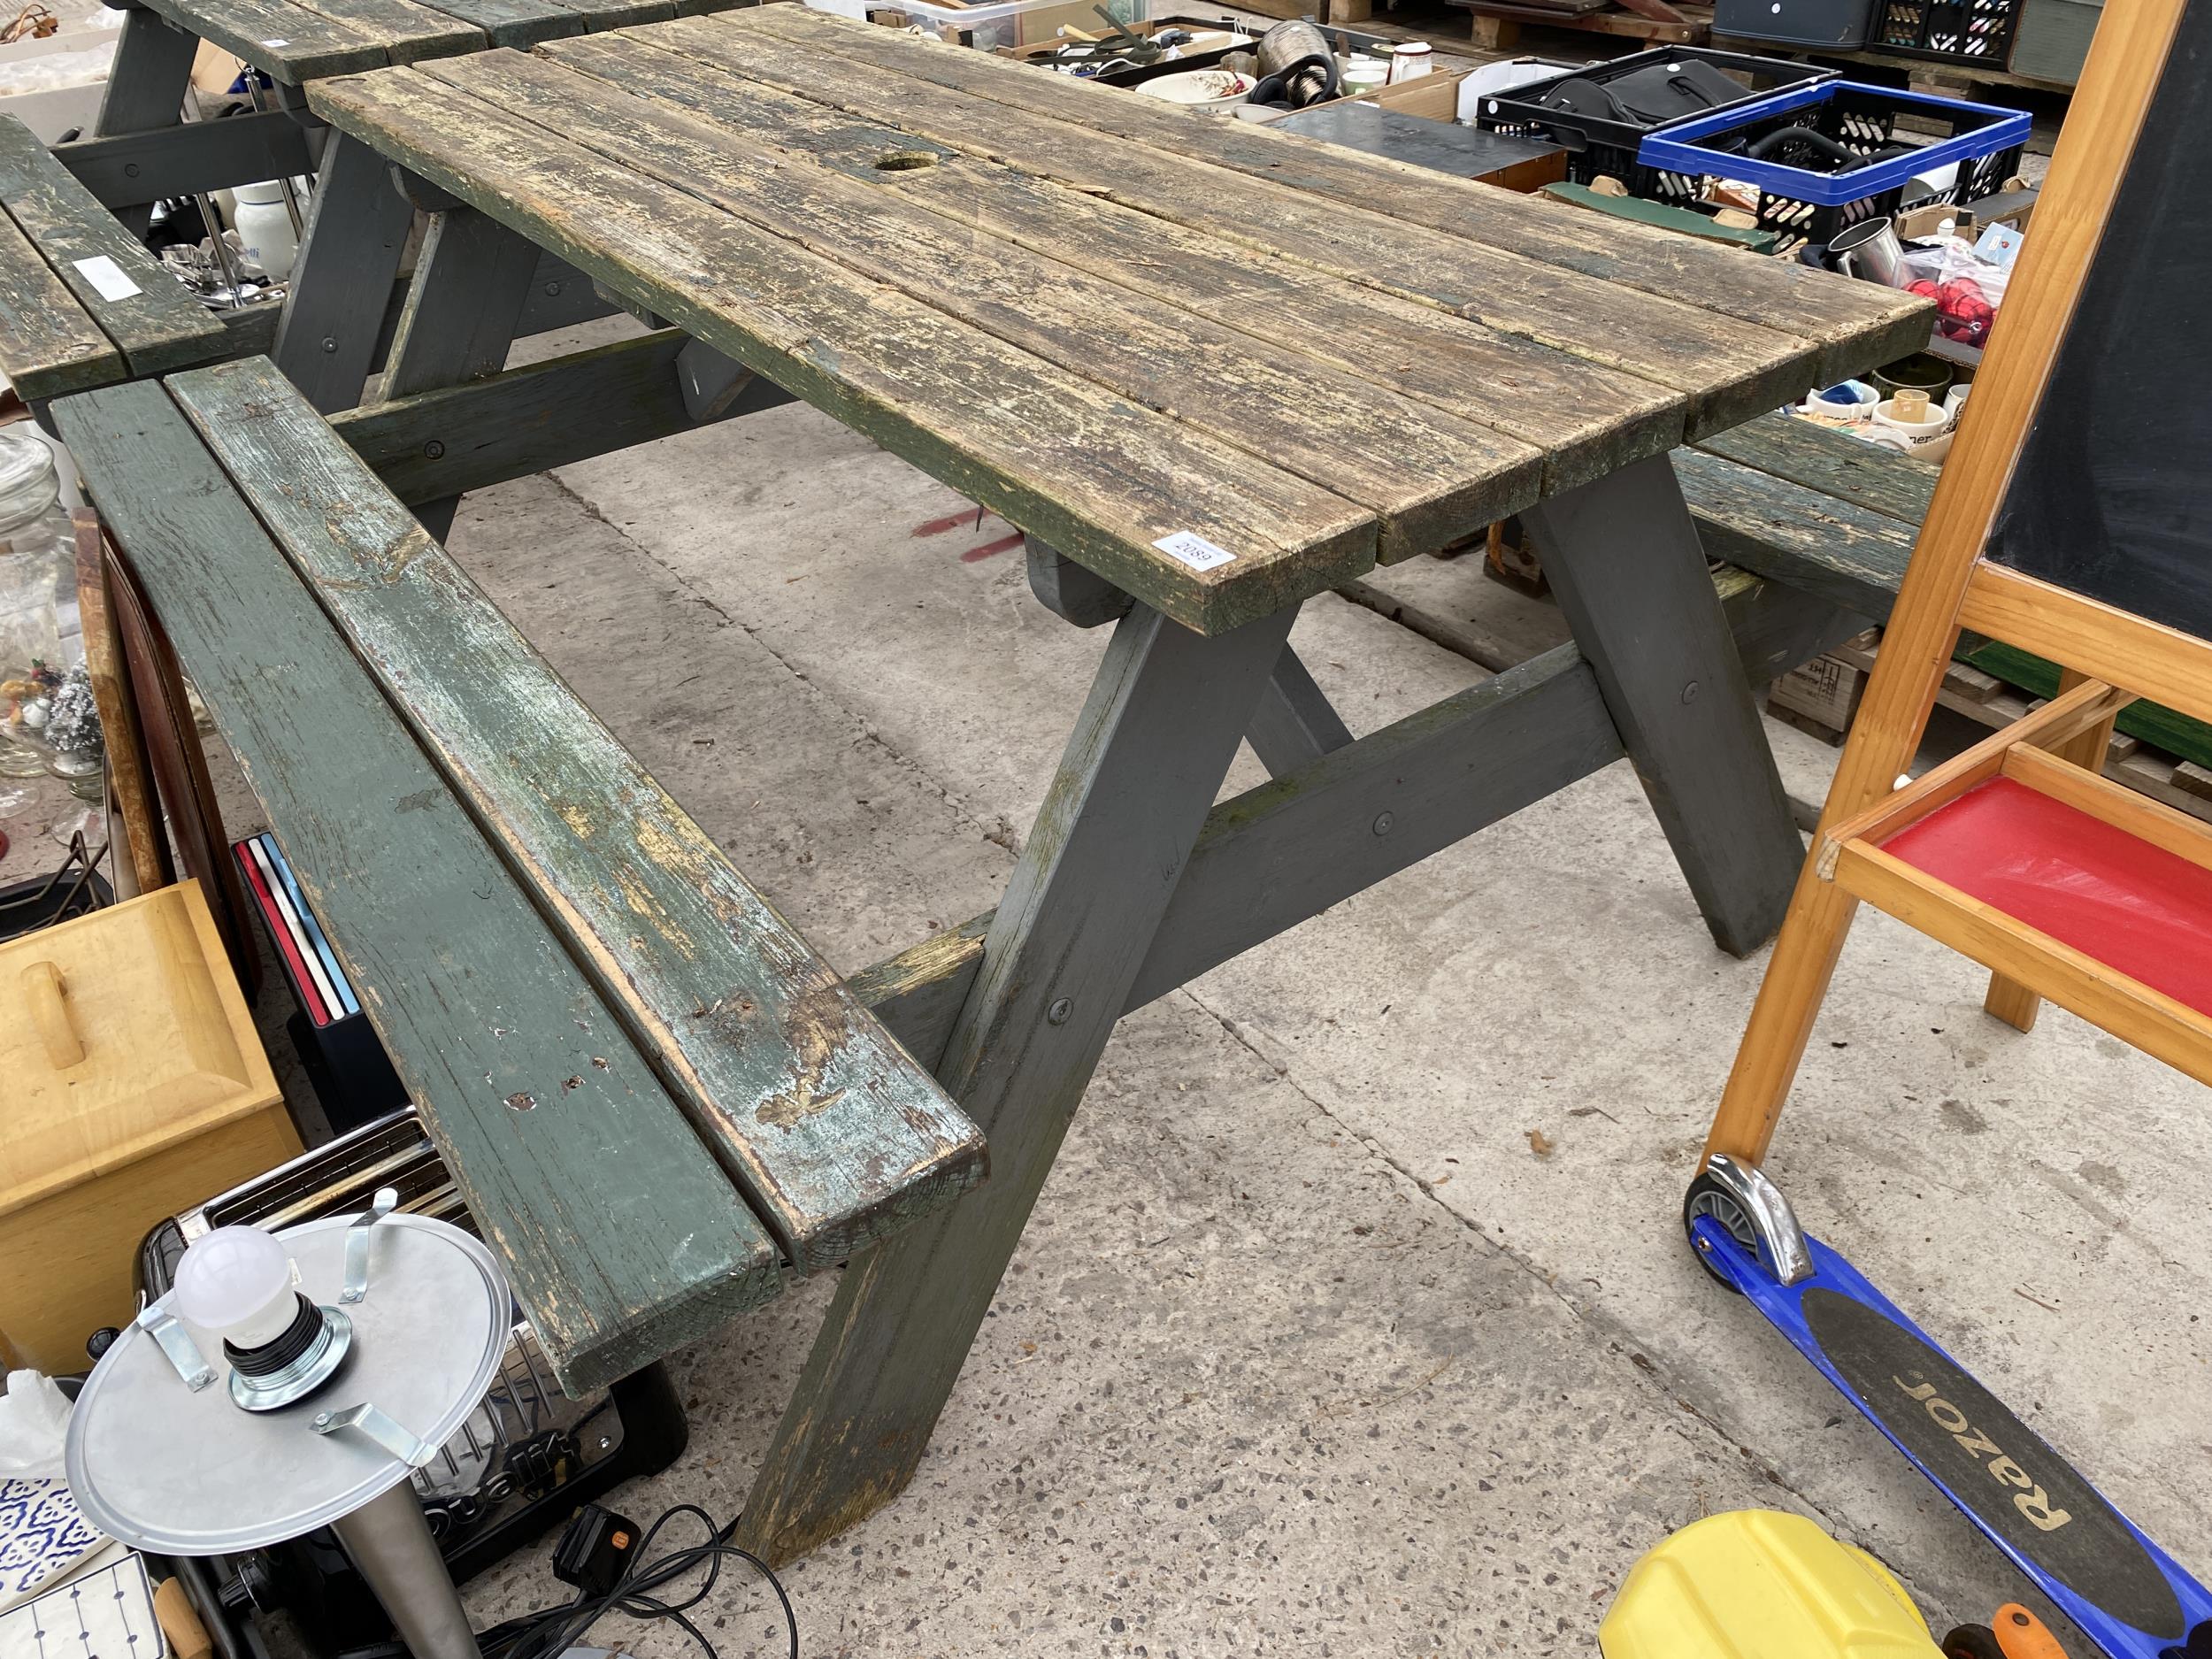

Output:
xmin=1706 ymin=0 xmax=2212 ymax=1164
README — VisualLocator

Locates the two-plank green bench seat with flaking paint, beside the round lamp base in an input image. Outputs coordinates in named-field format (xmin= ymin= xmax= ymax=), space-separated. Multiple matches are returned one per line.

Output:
xmin=51 ymin=358 xmax=985 ymax=1389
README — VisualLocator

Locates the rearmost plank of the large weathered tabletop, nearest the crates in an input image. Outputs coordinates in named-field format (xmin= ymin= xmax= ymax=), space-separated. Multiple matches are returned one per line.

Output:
xmin=728 ymin=7 xmax=1929 ymax=379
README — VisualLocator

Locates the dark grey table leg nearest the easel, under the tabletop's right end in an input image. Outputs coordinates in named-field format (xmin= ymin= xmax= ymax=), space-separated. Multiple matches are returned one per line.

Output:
xmin=1522 ymin=456 xmax=1805 ymax=956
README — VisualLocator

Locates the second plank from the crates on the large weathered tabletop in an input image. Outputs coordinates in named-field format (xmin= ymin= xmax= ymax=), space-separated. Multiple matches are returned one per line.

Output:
xmin=644 ymin=18 xmax=1818 ymax=432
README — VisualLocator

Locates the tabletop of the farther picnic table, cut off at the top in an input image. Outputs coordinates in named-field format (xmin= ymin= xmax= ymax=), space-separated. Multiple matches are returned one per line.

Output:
xmin=142 ymin=0 xmax=743 ymax=87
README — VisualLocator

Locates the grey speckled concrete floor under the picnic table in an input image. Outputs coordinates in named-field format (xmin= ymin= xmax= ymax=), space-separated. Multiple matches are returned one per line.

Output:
xmin=12 ymin=314 xmax=2212 ymax=1659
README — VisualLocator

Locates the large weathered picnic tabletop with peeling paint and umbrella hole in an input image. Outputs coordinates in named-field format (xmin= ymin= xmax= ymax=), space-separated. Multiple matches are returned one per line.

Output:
xmin=303 ymin=0 xmax=1927 ymax=633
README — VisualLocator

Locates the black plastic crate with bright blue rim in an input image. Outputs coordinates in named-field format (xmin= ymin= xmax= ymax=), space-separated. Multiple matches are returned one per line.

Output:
xmin=1637 ymin=80 xmax=2029 ymax=252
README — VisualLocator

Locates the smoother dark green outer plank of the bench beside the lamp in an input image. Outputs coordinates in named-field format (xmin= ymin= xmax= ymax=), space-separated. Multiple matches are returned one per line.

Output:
xmin=53 ymin=380 xmax=783 ymax=1389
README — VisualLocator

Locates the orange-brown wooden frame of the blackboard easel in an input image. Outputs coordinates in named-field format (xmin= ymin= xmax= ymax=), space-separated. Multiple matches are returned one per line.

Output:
xmin=1706 ymin=0 xmax=2212 ymax=1164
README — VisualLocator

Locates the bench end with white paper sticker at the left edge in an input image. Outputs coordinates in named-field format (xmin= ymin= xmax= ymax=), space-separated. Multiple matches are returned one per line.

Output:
xmin=0 ymin=115 xmax=228 ymax=403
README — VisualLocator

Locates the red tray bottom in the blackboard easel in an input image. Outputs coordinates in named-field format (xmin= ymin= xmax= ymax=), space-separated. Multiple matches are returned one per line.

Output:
xmin=1880 ymin=779 xmax=2212 ymax=1013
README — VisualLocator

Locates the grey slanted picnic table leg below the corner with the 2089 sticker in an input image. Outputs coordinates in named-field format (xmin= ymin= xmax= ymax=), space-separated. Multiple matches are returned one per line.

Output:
xmin=737 ymin=606 xmax=1294 ymax=1562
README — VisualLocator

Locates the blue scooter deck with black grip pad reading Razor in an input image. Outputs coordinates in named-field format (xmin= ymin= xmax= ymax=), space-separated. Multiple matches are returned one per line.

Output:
xmin=1694 ymin=1219 xmax=2212 ymax=1659
